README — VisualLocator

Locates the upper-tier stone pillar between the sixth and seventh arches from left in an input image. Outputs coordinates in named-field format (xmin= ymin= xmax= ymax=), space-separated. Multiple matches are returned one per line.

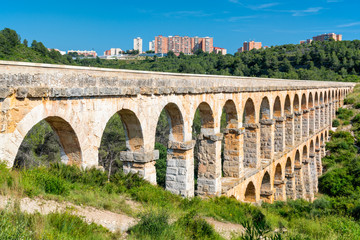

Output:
xmin=243 ymin=123 xmax=260 ymax=168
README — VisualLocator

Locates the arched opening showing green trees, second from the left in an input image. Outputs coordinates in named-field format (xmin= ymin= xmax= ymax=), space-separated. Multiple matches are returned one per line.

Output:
xmin=99 ymin=109 xmax=144 ymax=176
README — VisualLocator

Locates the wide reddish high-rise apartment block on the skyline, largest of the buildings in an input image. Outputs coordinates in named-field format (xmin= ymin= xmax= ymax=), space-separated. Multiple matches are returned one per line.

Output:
xmin=155 ymin=35 xmax=213 ymax=55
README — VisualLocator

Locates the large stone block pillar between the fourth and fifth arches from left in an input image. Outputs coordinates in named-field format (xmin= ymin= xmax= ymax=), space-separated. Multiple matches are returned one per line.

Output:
xmin=197 ymin=133 xmax=223 ymax=196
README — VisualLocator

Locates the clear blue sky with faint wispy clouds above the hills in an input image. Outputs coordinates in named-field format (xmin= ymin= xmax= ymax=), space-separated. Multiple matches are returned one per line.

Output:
xmin=0 ymin=0 xmax=360 ymax=55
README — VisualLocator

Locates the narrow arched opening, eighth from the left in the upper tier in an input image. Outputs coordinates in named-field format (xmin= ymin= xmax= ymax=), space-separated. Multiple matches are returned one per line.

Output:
xmin=273 ymin=97 xmax=285 ymax=152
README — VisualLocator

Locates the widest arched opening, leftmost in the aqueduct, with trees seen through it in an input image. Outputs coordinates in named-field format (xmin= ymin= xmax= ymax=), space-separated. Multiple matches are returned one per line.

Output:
xmin=13 ymin=116 xmax=82 ymax=168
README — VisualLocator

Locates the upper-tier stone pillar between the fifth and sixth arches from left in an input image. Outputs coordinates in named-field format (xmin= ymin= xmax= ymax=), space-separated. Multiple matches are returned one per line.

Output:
xmin=223 ymin=128 xmax=245 ymax=178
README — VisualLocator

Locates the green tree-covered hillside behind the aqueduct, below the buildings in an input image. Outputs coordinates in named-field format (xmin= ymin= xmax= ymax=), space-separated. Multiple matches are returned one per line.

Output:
xmin=0 ymin=28 xmax=360 ymax=82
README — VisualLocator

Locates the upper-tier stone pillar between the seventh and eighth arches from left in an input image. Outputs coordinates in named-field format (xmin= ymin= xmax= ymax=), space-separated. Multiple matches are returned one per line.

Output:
xmin=260 ymin=119 xmax=275 ymax=159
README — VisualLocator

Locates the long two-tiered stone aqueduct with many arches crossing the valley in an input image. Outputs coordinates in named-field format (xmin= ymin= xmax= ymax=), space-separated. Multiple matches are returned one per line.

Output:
xmin=0 ymin=61 xmax=354 ymax=202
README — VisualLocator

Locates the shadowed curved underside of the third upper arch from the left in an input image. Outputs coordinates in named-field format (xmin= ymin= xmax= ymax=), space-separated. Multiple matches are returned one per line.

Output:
xmin=164 ymin=103 xmax=184 ymax=142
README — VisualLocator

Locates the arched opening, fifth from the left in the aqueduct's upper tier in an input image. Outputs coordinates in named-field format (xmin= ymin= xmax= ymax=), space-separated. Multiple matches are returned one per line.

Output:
xmin=220 ymin=100 xmax=243 ymax=178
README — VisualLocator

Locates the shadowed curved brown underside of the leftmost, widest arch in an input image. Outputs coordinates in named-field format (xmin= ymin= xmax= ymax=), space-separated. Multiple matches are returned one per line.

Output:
xmin=15 ymin=116 xmax=82 ymax=167
